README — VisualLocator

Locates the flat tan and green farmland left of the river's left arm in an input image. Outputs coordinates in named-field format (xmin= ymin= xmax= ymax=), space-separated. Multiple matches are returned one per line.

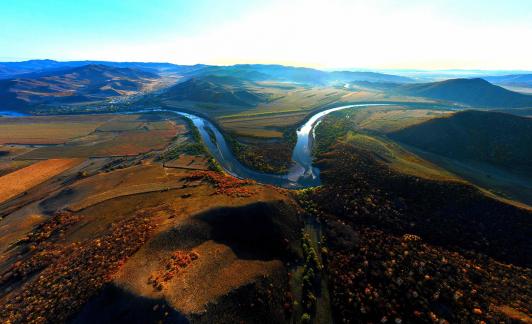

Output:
xmin=0 ymin=114 xmax=186 ymax=160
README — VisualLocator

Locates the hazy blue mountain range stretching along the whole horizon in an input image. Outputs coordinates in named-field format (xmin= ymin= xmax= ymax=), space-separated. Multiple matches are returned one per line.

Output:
xmin=0 ymin=60 xmax=532 ymax=110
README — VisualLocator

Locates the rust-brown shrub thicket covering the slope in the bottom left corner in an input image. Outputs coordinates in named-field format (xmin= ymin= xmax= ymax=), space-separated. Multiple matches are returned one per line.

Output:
xmin=0 ymin=210 xmax=153 ymax=323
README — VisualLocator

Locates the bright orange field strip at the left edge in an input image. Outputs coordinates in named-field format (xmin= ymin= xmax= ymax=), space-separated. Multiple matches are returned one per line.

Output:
xmin=0 ymin=159 xmax=81 ymax=203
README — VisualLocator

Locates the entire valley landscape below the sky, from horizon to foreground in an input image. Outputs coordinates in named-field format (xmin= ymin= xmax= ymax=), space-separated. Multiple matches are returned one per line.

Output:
xmin=0 ymin=62 xmax=532 ymax=323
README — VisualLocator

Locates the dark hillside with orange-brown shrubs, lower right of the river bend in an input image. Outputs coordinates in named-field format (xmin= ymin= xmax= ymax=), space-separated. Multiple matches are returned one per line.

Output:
xmin=300 ymin=143 xmax=532 ymax=323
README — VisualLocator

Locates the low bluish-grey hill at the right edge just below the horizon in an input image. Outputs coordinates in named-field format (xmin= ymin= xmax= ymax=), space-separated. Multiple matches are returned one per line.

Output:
xmin=391 ymin=78 xmax=532 ymax=108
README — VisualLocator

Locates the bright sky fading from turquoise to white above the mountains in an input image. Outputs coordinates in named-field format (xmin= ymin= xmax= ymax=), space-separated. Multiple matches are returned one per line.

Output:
xmin=0 ymin=0 xmax=532 ymax=70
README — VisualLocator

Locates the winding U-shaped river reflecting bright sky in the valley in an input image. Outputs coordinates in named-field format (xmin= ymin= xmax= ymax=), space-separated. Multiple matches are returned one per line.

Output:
xmin=158 ymin=104 xmax=384 ymax=189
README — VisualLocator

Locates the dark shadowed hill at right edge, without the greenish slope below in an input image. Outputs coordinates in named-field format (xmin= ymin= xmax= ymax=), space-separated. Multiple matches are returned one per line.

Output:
xmin=388 ymin=110 xmax=532 ymax=176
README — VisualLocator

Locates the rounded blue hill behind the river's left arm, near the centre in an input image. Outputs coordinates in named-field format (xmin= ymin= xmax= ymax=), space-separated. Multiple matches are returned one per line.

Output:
xmin=162 ymin=75 xmax=268 ymax=106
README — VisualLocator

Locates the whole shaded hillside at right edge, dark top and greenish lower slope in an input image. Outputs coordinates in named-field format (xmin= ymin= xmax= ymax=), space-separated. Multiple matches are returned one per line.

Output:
xmin=389 ymin=111 xmax=532 ymax=204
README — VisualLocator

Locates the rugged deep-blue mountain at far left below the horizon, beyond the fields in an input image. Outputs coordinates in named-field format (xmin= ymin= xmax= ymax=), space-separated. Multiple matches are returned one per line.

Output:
xmin=0 ymin=64 xmax=159 ymax=110
